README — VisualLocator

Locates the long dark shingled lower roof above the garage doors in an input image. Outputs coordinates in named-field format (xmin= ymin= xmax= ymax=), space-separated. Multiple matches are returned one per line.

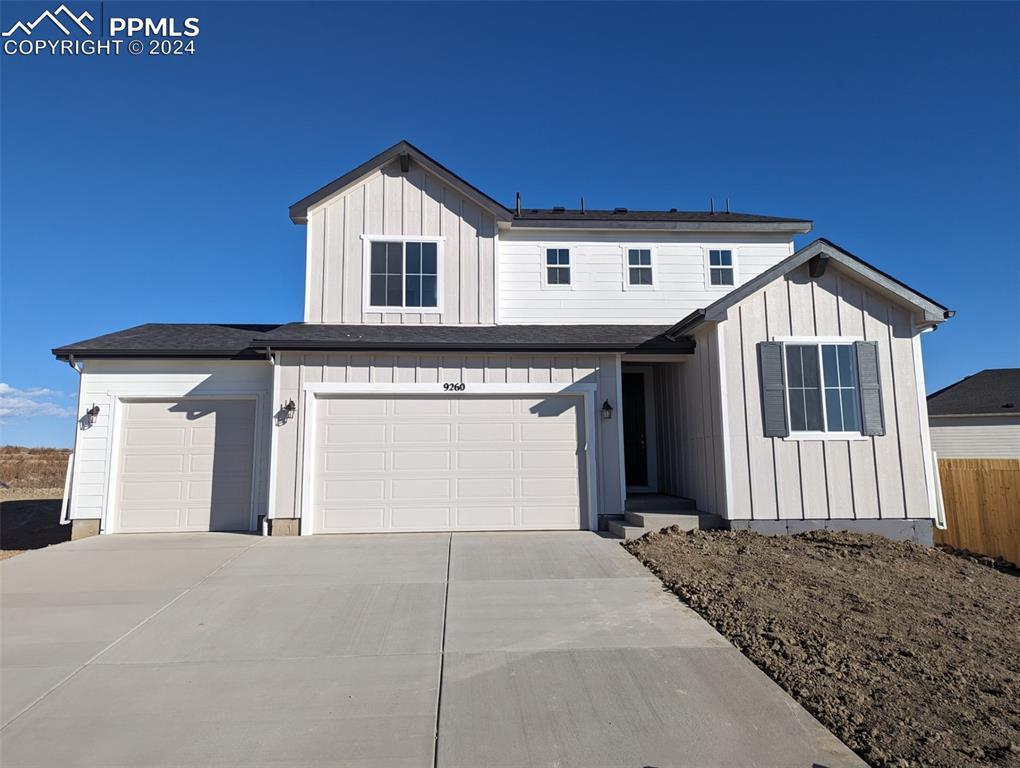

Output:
xmin=53 ymin=322 xmax=694 ymax=360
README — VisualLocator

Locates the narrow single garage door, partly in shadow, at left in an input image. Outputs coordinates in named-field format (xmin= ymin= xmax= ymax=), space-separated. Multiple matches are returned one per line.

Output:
xmin=114 ymin=398 xmax=255 ymax=532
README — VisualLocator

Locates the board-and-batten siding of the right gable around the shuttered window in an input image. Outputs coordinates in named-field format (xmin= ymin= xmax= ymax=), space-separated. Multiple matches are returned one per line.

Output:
xmin=705 ymin=265 xmax=931 ymax=520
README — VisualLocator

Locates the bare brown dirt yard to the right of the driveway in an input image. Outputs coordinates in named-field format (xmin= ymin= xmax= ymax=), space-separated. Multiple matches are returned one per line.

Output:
xmin=624 ymin=528 xmax=1020 ymax=768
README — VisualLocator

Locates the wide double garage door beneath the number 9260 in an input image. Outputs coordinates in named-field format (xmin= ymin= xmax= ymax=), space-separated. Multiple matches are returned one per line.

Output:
xmin=312 ymin=396 xmax=587 ymax=533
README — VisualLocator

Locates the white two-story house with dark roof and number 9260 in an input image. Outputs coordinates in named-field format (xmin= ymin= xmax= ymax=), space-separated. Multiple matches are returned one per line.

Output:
xmin=54 ymin=142 xmax=952 ymax=542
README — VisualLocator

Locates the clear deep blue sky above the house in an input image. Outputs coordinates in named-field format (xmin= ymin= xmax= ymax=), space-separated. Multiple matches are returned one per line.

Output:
xmin=0 ymin=0 xmax=1020 ymax=446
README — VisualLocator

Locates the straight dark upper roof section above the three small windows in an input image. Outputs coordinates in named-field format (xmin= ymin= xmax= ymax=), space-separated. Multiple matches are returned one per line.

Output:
xmin=512 ymin=208 xmax=812 ymax=234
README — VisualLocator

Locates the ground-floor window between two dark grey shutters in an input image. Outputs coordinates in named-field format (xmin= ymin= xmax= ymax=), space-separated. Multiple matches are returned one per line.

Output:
xmin=784 ymin=344 xmax=861 ymax=432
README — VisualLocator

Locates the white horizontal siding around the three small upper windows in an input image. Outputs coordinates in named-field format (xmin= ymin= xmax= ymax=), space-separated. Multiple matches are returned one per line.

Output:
xmin=498 ymin=227 xmax=794 ymax=324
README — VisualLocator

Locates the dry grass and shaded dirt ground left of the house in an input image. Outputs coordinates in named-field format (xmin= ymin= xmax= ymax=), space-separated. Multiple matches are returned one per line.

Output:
xmin=0 ymin=446 xmax=70 ymax=560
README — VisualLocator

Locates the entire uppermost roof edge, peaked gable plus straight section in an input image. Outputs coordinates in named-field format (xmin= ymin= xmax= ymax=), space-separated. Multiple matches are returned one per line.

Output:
xmin=290 ymin=140 xmax=812 ymax=234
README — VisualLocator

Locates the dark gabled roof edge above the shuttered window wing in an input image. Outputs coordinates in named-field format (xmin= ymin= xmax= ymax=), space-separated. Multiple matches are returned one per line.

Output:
xmin=666 ymin=238 xmax=954 ymax=338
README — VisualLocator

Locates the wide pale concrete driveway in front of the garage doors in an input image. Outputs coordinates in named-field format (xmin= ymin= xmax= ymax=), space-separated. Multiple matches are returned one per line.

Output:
xmin=0 ymin=532 xmax=864 ymax=768
